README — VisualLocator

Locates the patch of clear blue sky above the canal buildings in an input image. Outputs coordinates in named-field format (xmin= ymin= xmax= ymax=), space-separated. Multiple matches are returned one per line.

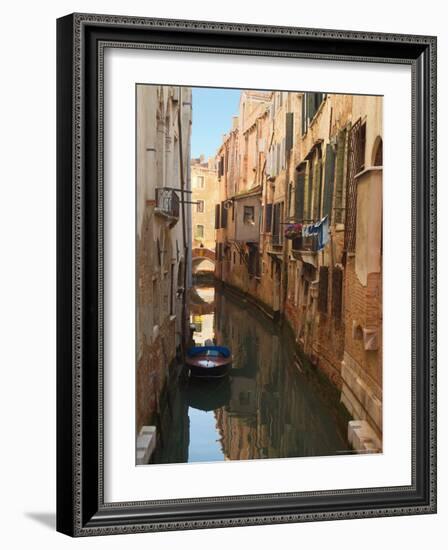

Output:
xmin=191 ymin=88 xmax=241 ymax=159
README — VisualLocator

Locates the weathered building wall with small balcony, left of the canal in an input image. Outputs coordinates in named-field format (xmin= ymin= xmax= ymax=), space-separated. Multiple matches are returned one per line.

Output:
xmin=136 ymin=85 xmax=192 ymax=440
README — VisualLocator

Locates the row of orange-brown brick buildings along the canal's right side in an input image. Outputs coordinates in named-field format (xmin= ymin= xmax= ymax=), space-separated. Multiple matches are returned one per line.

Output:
xmin=215 ymin=92 xmax=382 ymax=450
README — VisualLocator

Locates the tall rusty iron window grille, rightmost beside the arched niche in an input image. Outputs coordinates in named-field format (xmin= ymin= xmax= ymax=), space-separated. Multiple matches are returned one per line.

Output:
xmin=344 ymin=120 xmax=366 ymax=252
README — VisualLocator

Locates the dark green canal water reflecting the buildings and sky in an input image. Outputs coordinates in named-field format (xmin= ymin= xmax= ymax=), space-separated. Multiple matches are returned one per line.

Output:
xmin=152 ymin=285 xmax=352 ymax=464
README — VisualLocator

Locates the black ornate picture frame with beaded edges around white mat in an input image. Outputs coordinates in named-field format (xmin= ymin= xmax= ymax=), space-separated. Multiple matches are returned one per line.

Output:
xmin=57 ymin=14 xmax=436 ymax=536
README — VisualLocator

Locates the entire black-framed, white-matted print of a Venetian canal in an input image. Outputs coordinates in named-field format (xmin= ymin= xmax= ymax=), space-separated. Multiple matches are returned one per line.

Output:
xmin=57 ymin=14 xmax=436 ymax=536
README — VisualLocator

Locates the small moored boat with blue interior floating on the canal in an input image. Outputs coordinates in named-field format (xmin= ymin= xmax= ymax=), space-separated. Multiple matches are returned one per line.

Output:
xmin=185 ymin=346 xmax=232 ymax=378
